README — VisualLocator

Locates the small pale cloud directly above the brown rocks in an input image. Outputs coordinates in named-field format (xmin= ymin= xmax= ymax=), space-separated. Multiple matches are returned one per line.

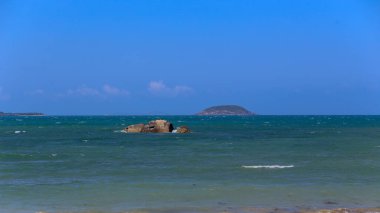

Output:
xmin=148 ymin=81 xmax=194 ymax=97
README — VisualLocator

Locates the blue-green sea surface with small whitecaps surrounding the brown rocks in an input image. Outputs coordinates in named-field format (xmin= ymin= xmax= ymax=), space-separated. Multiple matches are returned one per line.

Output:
xmin=0 ymin=116 xmax=380 ymax=213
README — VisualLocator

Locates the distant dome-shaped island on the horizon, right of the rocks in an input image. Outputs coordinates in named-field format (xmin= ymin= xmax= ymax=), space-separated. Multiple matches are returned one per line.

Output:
xmin=196 ymin=105 xmax=255 ymax=115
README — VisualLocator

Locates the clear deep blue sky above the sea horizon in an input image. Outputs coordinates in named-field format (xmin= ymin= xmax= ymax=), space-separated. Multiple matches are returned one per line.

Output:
xmin=0 ymin=0 xmax=380 ymax=115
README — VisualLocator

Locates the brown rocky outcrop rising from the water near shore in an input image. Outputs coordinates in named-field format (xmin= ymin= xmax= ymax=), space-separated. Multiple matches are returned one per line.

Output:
xmin=124 ymin=120 xmax=190 ymax=133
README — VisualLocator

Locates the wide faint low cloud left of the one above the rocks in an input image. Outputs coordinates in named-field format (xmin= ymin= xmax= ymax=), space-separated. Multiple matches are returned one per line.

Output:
xmin=66 ymin=84 xmax=130 ymax=97
